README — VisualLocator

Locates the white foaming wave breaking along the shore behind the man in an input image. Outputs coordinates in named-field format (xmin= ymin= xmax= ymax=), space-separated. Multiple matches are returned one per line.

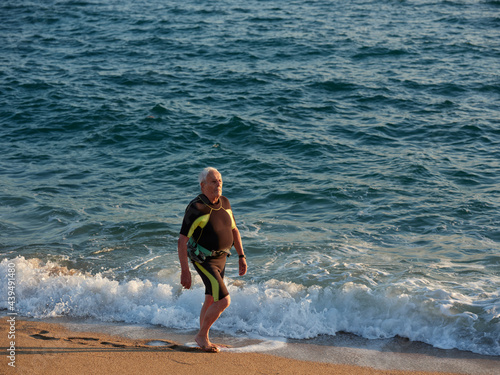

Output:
xmin=0 ymin=257 xmax=500 ymax=355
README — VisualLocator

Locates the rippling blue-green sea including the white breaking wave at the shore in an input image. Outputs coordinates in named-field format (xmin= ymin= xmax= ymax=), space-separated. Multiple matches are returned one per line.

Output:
xmin=0 ymin=0 xmax=500 ymax=356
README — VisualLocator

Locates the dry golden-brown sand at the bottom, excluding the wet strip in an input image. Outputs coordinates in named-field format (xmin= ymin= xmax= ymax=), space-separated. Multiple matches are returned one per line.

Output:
xmin=0 ymin=317 xmax=499 ymax=375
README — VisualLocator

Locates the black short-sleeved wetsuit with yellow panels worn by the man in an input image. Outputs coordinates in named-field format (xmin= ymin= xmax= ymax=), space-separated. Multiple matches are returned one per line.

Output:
xmin=180 ymin=194 xmax=236 ymax=302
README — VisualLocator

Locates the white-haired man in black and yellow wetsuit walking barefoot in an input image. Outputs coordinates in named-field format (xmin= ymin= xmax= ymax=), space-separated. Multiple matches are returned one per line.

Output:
xmin=177 ymin=168 xmax=247 ymax=353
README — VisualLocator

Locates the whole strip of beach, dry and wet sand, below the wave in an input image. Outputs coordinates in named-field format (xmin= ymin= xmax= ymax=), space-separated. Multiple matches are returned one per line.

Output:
xmin=0 ymin=316 xmax=500 ymax=375
